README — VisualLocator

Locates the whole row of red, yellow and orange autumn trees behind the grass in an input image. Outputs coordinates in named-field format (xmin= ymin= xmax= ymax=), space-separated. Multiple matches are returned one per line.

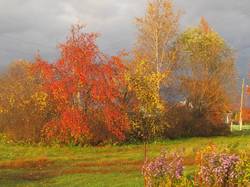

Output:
xmin=0 ymin=0 xmax=236 ymax=145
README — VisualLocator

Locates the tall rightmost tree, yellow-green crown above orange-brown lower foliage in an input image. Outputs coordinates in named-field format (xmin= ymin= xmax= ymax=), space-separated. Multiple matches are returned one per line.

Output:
xmin=170 ymin=18 xmax=236 ymax=135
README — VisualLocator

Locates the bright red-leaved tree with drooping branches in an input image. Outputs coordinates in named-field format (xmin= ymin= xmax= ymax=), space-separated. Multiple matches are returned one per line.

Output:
xmin=35 ymin=25 xmax=129 ymax=144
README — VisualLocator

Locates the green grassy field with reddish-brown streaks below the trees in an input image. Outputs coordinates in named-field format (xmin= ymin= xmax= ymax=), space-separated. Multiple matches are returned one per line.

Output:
xmin=0 ymin=126 xmax=250 ymax=187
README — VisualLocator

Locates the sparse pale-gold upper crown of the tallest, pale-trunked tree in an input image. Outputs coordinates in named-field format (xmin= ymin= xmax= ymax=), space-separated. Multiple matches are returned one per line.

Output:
xmin=134 ymin=0 xmax=180 ymax=75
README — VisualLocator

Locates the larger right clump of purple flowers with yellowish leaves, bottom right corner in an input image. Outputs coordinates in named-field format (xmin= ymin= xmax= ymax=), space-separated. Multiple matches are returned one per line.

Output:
xmin=196 ymin=146 xmax=249 ymax=187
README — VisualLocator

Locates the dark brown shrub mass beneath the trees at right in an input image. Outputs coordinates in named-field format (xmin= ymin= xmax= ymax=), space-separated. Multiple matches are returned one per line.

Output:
xmin=164 ymin=106 xmax=230 ymax=138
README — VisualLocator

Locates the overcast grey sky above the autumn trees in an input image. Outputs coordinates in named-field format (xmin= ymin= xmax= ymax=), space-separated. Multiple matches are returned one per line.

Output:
xmin=0 ymin=0 xmax=250 ymax=76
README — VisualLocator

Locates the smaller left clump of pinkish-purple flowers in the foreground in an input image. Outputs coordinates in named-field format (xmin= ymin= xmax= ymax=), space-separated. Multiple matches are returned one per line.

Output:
xmin=142 ymin=153 xmax=183 ymax=187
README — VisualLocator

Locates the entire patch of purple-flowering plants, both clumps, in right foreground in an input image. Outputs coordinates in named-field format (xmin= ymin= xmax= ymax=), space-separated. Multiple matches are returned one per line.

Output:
xmin=142 ymin=145 xmax=250 ymax=187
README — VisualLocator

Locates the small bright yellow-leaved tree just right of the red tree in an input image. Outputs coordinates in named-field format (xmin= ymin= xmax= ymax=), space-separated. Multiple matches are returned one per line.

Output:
xmin=126 ymin=61 xmax=166 ymax=140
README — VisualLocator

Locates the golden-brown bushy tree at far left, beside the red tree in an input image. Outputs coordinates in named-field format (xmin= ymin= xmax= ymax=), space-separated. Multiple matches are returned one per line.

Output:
xmin=0 ymin=61 xmax=51 ymax=142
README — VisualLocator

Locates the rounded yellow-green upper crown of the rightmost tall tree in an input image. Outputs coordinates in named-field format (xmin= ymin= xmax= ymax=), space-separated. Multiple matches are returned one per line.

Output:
xmin=179 ymin=20 xmax=230 ymax=74
